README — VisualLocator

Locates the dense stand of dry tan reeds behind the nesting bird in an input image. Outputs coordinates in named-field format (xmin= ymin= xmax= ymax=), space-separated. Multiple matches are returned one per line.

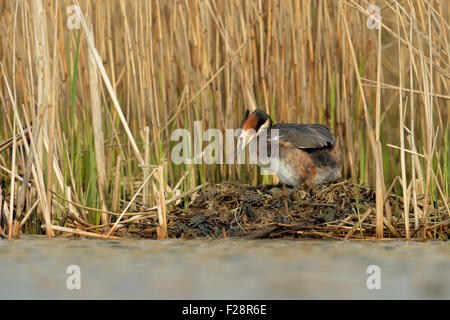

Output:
xmin=0 ymin=0 xmax=450 ymax=236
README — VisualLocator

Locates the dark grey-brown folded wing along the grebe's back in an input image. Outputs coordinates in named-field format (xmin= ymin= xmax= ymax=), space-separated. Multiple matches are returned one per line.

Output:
xmin=272 ymin=123 xmax=336 ymax=149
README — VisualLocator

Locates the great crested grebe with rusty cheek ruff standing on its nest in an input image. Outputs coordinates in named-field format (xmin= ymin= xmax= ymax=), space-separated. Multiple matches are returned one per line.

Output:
xmin=236 ymin=109 xmax=341 ymax=212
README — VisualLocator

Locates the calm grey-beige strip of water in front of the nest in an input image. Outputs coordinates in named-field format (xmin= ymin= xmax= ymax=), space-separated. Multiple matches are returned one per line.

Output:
xmin=0 ymin=240 xmax=450 ymax=299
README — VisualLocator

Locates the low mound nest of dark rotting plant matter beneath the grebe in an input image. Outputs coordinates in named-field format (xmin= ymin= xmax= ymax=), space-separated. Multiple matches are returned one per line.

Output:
xmin=131 ymin=181 xmax=448 ymax=239
